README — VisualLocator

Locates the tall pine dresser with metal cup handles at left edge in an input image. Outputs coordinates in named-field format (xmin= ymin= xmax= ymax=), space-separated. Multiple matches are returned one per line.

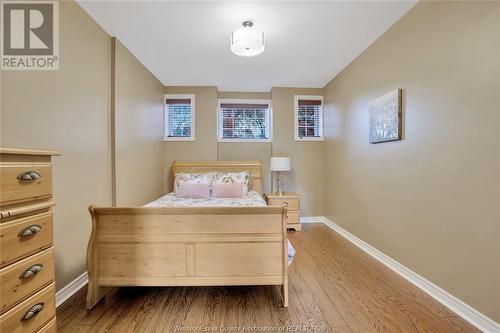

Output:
xmin=0 ymin=148 xmax=59 ymax=333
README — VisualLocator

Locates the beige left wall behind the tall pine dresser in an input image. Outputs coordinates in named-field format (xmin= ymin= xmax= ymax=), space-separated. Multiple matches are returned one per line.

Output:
xmin=0 ymin=1 xmax=164 ymax=290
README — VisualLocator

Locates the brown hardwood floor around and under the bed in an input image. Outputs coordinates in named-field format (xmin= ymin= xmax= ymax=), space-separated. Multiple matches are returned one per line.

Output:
xmin=57 ymin=224 xmax=479 ymax=333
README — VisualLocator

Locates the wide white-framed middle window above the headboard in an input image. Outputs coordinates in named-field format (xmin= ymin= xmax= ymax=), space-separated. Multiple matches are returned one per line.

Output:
xmin=217 ymin=99 xmax=272 ymax=142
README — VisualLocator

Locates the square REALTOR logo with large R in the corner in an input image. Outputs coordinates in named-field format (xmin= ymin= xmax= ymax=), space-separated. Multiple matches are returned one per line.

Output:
xmin=0 ymin=0 xmax=59 ymax=70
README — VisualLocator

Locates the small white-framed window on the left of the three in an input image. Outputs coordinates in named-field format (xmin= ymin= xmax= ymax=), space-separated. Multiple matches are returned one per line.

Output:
xmin=164 ymin=95 xmax=194 ymax=141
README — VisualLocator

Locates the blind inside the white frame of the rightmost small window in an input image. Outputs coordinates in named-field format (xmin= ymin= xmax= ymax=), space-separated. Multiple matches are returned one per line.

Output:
xmin=297 ymin=99 xmax=322 ymax=138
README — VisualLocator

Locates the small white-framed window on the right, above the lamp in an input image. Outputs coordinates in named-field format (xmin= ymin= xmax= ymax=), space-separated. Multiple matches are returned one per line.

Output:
xmin=295 ymin=96 xmax=323 ymax=141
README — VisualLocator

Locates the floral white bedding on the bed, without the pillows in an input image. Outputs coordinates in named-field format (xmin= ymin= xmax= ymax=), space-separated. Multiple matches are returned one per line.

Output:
xmin=144 ymin=191 xmax=296 ymax=265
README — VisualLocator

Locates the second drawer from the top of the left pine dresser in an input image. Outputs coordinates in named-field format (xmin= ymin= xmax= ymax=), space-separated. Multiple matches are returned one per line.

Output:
xmin=0 ymin=212 xmax=52 ymax=267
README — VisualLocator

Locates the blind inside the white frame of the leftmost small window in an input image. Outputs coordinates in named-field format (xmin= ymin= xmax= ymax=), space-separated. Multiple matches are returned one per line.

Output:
xmin=166 ymin=98 xmax=193 ymax=138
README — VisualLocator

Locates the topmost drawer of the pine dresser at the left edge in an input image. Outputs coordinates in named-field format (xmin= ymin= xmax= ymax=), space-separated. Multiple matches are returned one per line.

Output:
xmin=0 ymin=164 xmax=52 ymax=206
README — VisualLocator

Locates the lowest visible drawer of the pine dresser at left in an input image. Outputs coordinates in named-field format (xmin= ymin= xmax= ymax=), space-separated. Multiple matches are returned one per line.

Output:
xmin=0 ymin=283 xmax=55 ymax=333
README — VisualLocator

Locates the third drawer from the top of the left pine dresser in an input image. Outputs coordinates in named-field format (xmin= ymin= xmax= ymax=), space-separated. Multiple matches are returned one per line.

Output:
xmin=0 ymin=248 xmax=54 ymax=313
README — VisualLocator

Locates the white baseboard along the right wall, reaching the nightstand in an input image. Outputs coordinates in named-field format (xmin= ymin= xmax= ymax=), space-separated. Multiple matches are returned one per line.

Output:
xmin=301 ymin=216 xmax=500 ymax=333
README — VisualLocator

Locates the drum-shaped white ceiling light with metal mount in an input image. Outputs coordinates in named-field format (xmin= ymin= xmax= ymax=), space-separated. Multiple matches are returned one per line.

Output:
xmin=231 ymin=20 xmax=264 ymax=57
